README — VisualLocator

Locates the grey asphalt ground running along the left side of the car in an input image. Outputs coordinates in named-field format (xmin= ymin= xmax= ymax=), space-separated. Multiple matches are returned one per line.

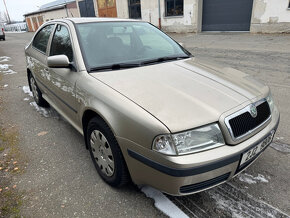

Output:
xmin=0 ymin=33 xmax=164 ymax=217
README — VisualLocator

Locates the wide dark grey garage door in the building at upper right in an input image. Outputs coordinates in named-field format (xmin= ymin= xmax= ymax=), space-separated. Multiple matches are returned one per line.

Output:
xmin=202 ymin=0 xmax=253 ymax=31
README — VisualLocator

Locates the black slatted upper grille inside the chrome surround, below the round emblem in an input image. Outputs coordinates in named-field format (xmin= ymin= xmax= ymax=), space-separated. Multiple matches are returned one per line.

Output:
xmin=229 ymin=101 xmax=271 ymax=138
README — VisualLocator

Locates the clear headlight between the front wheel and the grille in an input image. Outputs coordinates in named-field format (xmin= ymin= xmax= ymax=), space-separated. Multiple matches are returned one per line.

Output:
xmin=152 ymin=124 xmax=225 ymax=155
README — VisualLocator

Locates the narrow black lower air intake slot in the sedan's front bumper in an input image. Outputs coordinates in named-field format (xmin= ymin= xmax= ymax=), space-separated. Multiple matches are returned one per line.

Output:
xmin=179 ymin=173 xmax=231 ymax=193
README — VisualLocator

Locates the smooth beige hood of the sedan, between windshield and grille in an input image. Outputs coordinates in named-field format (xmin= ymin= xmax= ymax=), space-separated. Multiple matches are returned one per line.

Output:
xmin=91 ymin=58 xmax=269 ymax=132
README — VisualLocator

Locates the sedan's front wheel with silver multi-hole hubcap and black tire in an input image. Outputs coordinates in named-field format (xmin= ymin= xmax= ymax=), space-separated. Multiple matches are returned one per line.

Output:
xmin=86 ymin=117 xmax=129 ymax=187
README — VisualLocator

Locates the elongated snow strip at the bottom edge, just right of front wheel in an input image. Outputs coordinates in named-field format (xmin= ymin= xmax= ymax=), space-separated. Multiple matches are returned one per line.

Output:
xmin=141 ymin=186 xmax=188 ymax=218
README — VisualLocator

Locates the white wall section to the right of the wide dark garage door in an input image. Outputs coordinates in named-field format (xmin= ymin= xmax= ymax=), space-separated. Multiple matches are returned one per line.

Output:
xmin=251 ymin=0 xmax=290 ymax=33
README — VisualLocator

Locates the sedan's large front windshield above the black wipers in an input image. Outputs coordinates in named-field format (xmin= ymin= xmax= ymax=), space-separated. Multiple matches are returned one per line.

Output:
xmin=76 ymin=22 xmax=190 ymax=71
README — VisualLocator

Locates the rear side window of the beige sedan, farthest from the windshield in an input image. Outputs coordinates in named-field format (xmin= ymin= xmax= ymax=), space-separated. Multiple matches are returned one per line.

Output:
xmin=32 ymin=24 xmax=54 ymax=53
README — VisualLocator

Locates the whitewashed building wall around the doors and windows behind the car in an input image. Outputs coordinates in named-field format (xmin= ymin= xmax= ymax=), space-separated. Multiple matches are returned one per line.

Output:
xmin=76 ymin=0 xmax=290 ymax=33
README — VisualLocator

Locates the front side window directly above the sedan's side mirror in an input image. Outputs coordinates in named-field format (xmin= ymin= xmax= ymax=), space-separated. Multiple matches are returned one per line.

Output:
xmin=50 ymin=25 xmax=73 ymax=61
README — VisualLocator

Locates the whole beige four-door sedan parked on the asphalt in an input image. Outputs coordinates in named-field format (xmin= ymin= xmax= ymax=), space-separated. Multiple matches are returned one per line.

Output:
xmin=25 ymin=18 xmax=279 ymax=195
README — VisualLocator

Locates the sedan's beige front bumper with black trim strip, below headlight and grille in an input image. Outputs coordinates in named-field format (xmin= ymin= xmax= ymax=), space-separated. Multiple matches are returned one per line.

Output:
xmin=118 ymin=107 xmax=280 ymax=195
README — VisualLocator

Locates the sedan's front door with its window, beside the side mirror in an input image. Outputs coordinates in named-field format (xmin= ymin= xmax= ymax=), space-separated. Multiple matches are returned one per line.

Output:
xmin=47 ymin=24 xmax=78 ymax=122
